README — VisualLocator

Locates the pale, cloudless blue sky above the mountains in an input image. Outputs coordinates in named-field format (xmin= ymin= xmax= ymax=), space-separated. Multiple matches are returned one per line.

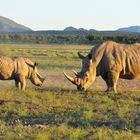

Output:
xmin=0 ymin=0 xmax=140 ymax=30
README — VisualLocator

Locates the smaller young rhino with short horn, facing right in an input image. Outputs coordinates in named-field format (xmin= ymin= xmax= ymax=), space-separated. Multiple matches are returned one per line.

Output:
xmin=0 ymin=56 xmax=45 ymax=90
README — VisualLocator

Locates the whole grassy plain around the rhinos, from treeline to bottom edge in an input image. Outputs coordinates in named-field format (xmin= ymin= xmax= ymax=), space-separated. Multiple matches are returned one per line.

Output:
xmin=0 ymin=44 xmax=140 ymax=140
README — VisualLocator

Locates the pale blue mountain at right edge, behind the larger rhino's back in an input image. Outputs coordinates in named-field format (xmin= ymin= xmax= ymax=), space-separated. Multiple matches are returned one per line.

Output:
xmin=117 ymin=26 xmax=140 ymax=32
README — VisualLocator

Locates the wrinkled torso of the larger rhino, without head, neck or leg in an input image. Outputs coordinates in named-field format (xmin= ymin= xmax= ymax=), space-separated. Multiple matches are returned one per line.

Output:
xmin=98 ymin=41 xmax=140 ymax=79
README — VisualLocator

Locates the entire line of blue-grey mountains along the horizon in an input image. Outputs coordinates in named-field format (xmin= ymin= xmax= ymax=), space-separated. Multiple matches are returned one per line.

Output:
xmin=0 ymin=16 xmax=140 ymax=35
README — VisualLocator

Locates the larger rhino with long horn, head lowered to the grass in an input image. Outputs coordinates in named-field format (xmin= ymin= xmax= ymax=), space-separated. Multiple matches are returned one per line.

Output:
xmin=64 ymin=41 xmax=140 ymax=93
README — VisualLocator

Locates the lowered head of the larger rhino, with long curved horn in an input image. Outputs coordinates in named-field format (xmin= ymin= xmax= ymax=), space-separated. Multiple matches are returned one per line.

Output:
xmin=64 ymin=53 xmax=96 ymax=90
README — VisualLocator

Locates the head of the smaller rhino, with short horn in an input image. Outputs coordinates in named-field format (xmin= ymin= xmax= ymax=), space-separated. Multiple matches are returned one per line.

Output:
xmin=30 ymin=62 xmax=45 ymax=86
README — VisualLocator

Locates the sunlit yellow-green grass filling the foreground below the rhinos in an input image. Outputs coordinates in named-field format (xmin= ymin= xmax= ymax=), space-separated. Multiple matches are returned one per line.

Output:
xmin=0 ymin=89 xmax=140 ymax=140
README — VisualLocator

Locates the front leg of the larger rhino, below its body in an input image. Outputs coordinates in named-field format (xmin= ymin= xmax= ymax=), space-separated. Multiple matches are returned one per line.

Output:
xmin=105 ymin=71 xmax=119 ymax=93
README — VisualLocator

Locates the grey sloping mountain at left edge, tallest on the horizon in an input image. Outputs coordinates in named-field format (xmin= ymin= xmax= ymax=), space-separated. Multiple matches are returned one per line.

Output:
xmin=0 ymin=16 xmax=32 ymax=33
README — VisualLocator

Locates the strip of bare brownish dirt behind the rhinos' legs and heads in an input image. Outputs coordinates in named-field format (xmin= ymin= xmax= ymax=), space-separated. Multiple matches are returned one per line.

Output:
xmin=0 ymin=70 xmax=140 ymax=92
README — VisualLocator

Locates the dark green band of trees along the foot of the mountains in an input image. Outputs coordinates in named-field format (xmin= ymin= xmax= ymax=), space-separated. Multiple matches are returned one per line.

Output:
xmin=0 ymin=32 xmax=140 ymax=44
